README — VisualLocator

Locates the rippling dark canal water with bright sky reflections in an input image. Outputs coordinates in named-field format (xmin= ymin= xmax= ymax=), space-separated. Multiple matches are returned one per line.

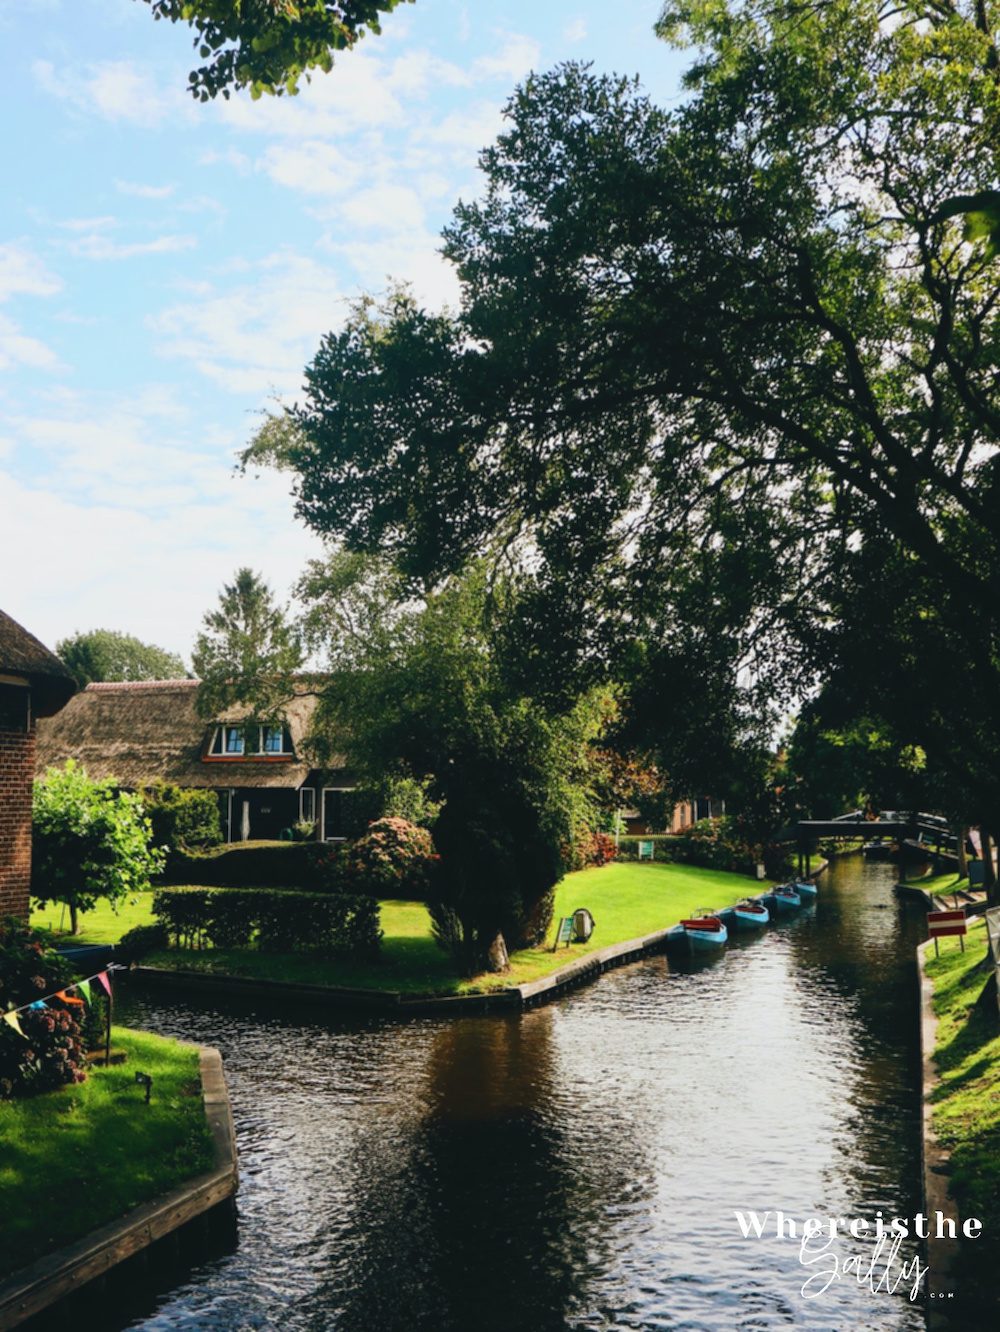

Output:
xmin=111 ymin=856 xmax=924 ymax=1332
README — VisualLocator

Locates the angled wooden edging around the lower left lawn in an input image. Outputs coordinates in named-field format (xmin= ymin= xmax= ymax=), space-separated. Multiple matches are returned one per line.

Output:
xmin=0 ymin=1046 xmax=238 ymax=1332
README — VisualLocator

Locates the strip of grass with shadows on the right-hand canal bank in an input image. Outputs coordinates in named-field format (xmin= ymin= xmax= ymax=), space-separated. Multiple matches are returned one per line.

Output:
xmin=925 ymin=918 xmax=1000 ymax=1237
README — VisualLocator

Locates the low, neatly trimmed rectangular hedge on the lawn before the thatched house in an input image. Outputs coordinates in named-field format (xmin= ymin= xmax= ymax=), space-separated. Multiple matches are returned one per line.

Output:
xmin=153 ymin=888 xmax=382 ymax=958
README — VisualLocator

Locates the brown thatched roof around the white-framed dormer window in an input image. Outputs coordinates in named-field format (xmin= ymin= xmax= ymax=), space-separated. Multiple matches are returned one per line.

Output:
xmin=37 ymin=679 xmax=336 ymax=789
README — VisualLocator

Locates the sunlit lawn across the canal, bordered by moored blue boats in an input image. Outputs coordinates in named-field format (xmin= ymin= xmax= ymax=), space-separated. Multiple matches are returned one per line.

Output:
xmin=103 ymin=862 xmax=759 ymax=994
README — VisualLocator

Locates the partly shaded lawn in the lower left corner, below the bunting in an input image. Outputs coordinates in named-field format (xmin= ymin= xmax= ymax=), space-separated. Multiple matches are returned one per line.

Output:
xmin=0 ymin=1028 xmax=212 ymax=1275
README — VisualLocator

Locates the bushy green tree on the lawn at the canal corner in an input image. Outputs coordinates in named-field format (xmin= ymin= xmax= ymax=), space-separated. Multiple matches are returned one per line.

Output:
xmin=300 ymin=559 xmax=615 ymax=972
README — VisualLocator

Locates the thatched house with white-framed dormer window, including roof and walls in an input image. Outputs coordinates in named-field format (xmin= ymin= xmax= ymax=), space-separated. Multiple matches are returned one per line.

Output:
xmin=37 ymin=679 xmax=352 ymax=840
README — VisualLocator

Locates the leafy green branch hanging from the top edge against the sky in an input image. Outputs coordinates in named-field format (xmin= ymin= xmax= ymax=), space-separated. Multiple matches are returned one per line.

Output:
xmin=145 ymin=0 xmax=411 ymax=101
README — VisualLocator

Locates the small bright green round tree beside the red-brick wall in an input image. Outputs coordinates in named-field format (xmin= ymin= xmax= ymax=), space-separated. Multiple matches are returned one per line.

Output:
xmin=32 ymin=759 xmax=165 ymax=934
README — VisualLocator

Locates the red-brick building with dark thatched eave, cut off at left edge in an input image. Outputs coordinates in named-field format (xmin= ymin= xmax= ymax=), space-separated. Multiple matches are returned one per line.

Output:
xmin=0 ymin=610 xmax=76 ymax=916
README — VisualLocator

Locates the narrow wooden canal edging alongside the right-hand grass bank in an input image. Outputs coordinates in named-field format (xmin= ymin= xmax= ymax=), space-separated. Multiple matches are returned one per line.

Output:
xmin=916 ymin=939 xmax=959 ymax=1329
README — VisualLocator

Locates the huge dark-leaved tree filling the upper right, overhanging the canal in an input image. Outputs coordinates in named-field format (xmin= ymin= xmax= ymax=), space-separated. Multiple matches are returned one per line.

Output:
xmin=251 ymin=0 xmax=1000 ymax=841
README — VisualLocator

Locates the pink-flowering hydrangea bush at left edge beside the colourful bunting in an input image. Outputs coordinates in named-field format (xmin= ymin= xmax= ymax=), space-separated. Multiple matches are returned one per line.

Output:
xmin=0 ymin=918 xmax=87 ymax=1099
